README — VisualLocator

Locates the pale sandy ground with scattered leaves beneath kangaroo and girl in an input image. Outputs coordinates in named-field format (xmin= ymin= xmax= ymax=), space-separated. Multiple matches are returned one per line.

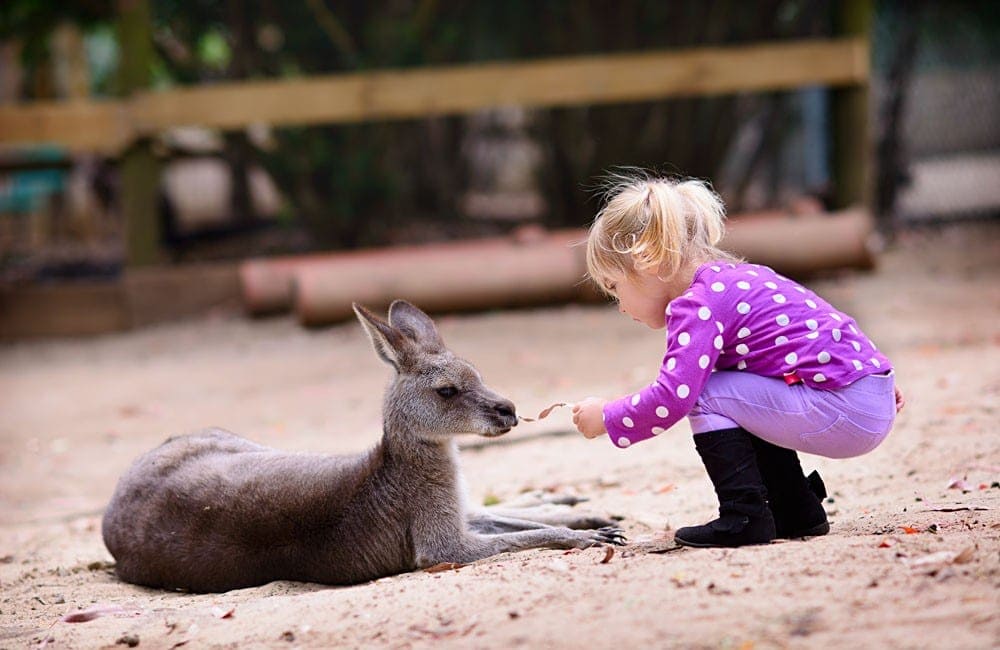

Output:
xmin=0 ymin=223 xmax=1000 ymax=648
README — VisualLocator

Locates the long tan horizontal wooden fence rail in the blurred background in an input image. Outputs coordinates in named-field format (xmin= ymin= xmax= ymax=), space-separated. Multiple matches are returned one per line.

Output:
xmin=0 ymin=37 xmax=869 ymax=153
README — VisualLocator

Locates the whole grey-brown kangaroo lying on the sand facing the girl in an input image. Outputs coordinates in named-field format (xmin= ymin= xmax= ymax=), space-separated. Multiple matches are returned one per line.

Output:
xmin=102 ymin=300 xmax=624 ymax=592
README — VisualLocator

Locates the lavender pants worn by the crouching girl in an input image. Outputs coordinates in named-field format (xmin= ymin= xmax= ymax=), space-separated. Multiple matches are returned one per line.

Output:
xmin=688 ymin=371 xmax=896 ymax=458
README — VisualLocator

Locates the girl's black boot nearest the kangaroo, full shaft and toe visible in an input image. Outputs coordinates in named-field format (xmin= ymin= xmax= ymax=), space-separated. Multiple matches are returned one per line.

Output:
xmin=674 ymin=428 xmax=775 ymax=546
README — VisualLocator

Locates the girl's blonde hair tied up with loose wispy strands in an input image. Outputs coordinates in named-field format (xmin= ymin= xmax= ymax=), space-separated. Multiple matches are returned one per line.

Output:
xmin=587 ymin=171 xmax=739 ymax=293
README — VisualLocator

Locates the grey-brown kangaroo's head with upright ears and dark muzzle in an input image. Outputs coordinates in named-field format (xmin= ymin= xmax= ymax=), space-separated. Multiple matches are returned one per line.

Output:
xmin=354 ymin=300 xmax=517 ymax=441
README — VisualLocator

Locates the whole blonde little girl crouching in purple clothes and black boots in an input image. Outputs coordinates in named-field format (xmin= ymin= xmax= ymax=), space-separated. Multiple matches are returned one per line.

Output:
xmin=573 ymin=173 xmax=902 ymax=546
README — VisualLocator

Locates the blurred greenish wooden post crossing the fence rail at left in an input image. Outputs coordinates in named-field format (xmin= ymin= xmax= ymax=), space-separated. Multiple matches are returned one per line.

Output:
xmin=117 ymin=0 xmax=163 ymax=267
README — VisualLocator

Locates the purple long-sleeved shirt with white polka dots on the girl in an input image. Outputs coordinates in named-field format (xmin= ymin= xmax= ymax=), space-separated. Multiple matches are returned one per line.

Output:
xmin=604 ymin=262 xmax=892 ymax=447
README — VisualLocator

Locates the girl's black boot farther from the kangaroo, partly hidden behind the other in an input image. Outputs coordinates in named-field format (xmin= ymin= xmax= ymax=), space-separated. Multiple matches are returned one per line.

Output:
xmin=750 ymin=435 xmax=830 ymax=539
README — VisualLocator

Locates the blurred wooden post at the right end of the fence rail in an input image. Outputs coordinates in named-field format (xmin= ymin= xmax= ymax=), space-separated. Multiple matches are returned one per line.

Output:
xmin=832 ymin=0 xmax=874 ymax=209
